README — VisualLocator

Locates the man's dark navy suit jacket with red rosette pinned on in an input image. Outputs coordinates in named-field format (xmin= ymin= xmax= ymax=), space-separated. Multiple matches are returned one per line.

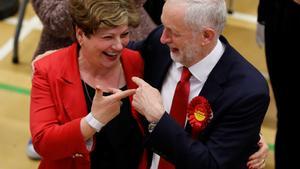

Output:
xmin=131 ymin=27 xmax=269 ymax=169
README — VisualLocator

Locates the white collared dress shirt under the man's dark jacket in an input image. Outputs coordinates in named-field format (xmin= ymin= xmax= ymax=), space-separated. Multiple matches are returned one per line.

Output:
xmin=150 ymin=40 xmax=224 ymax=169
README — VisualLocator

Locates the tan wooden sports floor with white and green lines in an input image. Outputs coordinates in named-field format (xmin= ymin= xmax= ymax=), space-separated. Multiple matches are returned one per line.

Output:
xmin=0 ymin=0 xmax=276 ymax=169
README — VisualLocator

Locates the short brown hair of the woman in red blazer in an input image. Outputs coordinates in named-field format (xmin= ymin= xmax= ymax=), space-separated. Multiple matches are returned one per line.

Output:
xmin=69 ymin=0 xmax=139 ymax=36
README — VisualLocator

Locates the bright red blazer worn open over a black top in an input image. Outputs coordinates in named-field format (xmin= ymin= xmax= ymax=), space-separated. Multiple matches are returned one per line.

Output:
xmin=30 ymin=43 xmax=143 ymax=169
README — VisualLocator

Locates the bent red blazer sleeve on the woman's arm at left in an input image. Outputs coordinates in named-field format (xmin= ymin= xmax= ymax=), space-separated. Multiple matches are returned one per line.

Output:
xmin=30 ymin=60 xmax=89 ymax=160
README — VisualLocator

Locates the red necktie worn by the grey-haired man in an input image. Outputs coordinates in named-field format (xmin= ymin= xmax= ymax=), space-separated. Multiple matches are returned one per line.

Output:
xmin=158 ymin=67 xmax=191 ymax=169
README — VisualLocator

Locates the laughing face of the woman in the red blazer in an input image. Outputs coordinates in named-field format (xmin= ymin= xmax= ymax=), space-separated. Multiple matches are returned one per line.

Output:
xmin=76 ymin=25 xmax=129 ymax=68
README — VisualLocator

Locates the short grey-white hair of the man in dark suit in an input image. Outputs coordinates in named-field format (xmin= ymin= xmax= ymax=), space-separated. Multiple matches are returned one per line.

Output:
xmin=184 ymin=0 xmax=227 ymax=34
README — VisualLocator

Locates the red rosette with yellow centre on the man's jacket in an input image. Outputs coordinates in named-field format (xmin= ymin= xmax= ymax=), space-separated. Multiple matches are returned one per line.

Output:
xmin=187 ymin=96 xmax=212 ymax=132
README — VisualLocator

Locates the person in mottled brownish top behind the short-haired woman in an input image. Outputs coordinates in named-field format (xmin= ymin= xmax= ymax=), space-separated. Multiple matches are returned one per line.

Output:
xmin=31 ymin=0 xmax=162 ymax=57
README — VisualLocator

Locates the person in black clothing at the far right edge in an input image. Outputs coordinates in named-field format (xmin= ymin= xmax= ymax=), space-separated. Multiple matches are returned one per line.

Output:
xmin=257 ymin=0 xmax=300 ymax=169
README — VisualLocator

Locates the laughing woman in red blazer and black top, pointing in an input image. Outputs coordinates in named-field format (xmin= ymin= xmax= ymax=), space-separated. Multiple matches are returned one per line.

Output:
xmin=30 ymin=0 xmax=143 ymax=169
